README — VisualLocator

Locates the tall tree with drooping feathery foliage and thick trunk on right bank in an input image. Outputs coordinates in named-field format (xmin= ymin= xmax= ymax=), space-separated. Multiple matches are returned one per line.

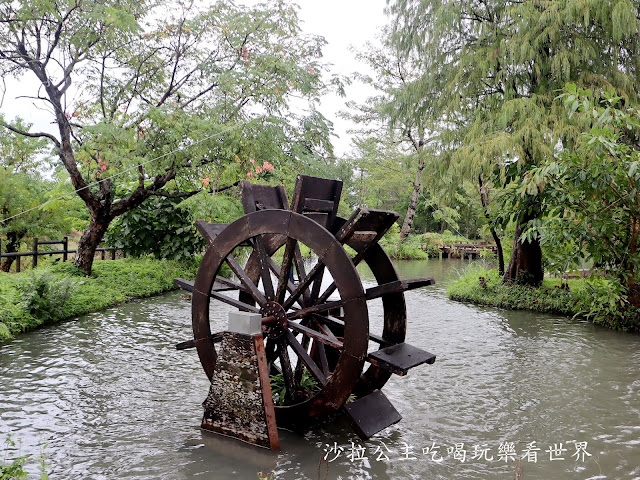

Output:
xmin=389 ymin=0 xmax=640 ymax=284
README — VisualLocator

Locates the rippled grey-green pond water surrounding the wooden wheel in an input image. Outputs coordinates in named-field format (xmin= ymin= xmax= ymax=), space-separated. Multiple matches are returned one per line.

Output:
xmin=0 ymin=260 xmax=640 ymax=479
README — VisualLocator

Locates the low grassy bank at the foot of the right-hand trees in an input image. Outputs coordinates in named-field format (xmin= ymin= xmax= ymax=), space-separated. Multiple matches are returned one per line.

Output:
xmin=447 ymin=264 xmax=640 ymax=331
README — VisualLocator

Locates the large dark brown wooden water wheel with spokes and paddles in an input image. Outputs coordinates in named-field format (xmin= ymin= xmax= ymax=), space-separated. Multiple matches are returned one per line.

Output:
xmin=176 ymin=176 xmax=435 ymax=438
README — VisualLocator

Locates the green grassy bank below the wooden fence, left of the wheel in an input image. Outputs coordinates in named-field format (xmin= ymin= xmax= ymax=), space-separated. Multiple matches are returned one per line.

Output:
xmin=0 ymin=258 xmax=198 ymax=341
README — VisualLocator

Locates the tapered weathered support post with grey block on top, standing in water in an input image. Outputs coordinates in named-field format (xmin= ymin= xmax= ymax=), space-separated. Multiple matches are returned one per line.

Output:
xmin=202 ymin=312 xmax=280 ymax=450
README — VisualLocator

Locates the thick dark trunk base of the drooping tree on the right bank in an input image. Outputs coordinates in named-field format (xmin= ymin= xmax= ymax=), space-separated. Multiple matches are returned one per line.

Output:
xmin=503 ymin=219 xmax=544 ymax=286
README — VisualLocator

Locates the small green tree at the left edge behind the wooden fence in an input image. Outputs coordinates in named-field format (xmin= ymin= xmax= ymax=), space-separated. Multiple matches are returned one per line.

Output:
xmin=0 ymin=118 xmax=69 ymax=272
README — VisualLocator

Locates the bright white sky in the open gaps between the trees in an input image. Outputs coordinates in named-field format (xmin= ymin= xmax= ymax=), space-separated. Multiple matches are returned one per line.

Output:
xmin=0 ymin=0 xmax=387 ymax=157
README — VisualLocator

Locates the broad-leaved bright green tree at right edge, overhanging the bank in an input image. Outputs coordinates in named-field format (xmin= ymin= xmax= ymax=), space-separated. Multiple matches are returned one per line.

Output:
xmin=523 ymin=84 xmax=640 ymax=305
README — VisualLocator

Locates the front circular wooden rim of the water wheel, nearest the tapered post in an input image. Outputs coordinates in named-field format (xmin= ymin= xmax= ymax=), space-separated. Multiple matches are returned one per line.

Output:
xmin=192 ymin=210 xmax=369 ymax=421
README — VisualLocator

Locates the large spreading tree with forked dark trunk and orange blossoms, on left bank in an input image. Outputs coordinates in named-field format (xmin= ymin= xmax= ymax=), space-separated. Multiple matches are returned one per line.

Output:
xmin=0 ymin=0 xmax=336 ymax=273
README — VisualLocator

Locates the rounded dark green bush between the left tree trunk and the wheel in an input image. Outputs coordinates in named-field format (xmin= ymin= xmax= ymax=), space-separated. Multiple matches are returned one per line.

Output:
xmin=105 ymin=194 xmax=206 ymax=260
